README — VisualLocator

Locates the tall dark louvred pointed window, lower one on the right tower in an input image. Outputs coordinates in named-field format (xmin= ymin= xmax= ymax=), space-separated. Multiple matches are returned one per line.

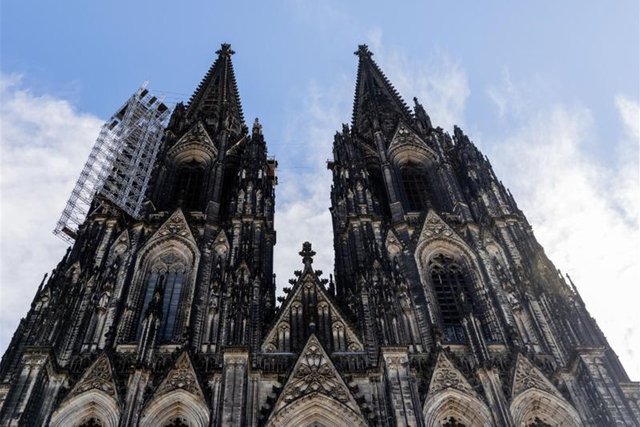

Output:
xmin=429 ymin=253 xmax=471 ymax=342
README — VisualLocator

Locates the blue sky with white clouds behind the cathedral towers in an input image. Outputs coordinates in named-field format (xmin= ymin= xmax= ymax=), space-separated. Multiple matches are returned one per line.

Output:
xmin=0 ymin=0 xmax=640 ymax=380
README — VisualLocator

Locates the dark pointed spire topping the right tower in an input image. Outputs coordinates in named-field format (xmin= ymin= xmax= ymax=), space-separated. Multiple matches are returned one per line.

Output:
xmin=352 ymin=45 xmax=412 ymax=138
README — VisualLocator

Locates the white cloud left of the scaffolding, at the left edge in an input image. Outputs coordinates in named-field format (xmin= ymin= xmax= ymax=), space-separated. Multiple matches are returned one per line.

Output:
xmin=0 ymin=74 xmax=102 ymax=349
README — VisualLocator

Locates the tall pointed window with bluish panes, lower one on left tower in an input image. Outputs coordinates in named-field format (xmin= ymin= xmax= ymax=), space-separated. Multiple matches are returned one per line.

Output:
xmin=137 ymin=252 xmax=188 ymax=343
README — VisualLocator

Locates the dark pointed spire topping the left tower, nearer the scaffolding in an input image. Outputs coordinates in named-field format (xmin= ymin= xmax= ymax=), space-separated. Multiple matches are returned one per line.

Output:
xmin=187 ymin=43 xmax=245 ymax=134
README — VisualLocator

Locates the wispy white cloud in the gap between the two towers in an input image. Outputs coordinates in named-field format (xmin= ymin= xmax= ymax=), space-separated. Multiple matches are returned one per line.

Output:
xmin=274 ymin=76 xmax=353 ymax=287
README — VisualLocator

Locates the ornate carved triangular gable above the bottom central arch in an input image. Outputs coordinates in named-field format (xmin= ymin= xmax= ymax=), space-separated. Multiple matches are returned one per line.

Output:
xmin=272 ymin=334 xmax=362 ymax=416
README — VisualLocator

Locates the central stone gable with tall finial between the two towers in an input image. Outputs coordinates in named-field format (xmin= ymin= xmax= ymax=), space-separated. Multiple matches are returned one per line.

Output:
xmin=262 ymin=242 xmax=364 ymax=352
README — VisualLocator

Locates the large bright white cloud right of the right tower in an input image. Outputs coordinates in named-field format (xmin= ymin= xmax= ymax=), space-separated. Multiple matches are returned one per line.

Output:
xmin=490 ymin=98 xmax=640 ymax=378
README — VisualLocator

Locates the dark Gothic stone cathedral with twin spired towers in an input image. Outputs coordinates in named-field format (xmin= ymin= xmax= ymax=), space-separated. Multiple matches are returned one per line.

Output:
xmin=0 ymin=44 xmax=640 ymax=427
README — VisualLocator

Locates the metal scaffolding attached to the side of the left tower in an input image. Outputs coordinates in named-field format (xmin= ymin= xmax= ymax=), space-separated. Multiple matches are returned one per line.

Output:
xmin=53 ymin=83 xmax=170 ymax=243
